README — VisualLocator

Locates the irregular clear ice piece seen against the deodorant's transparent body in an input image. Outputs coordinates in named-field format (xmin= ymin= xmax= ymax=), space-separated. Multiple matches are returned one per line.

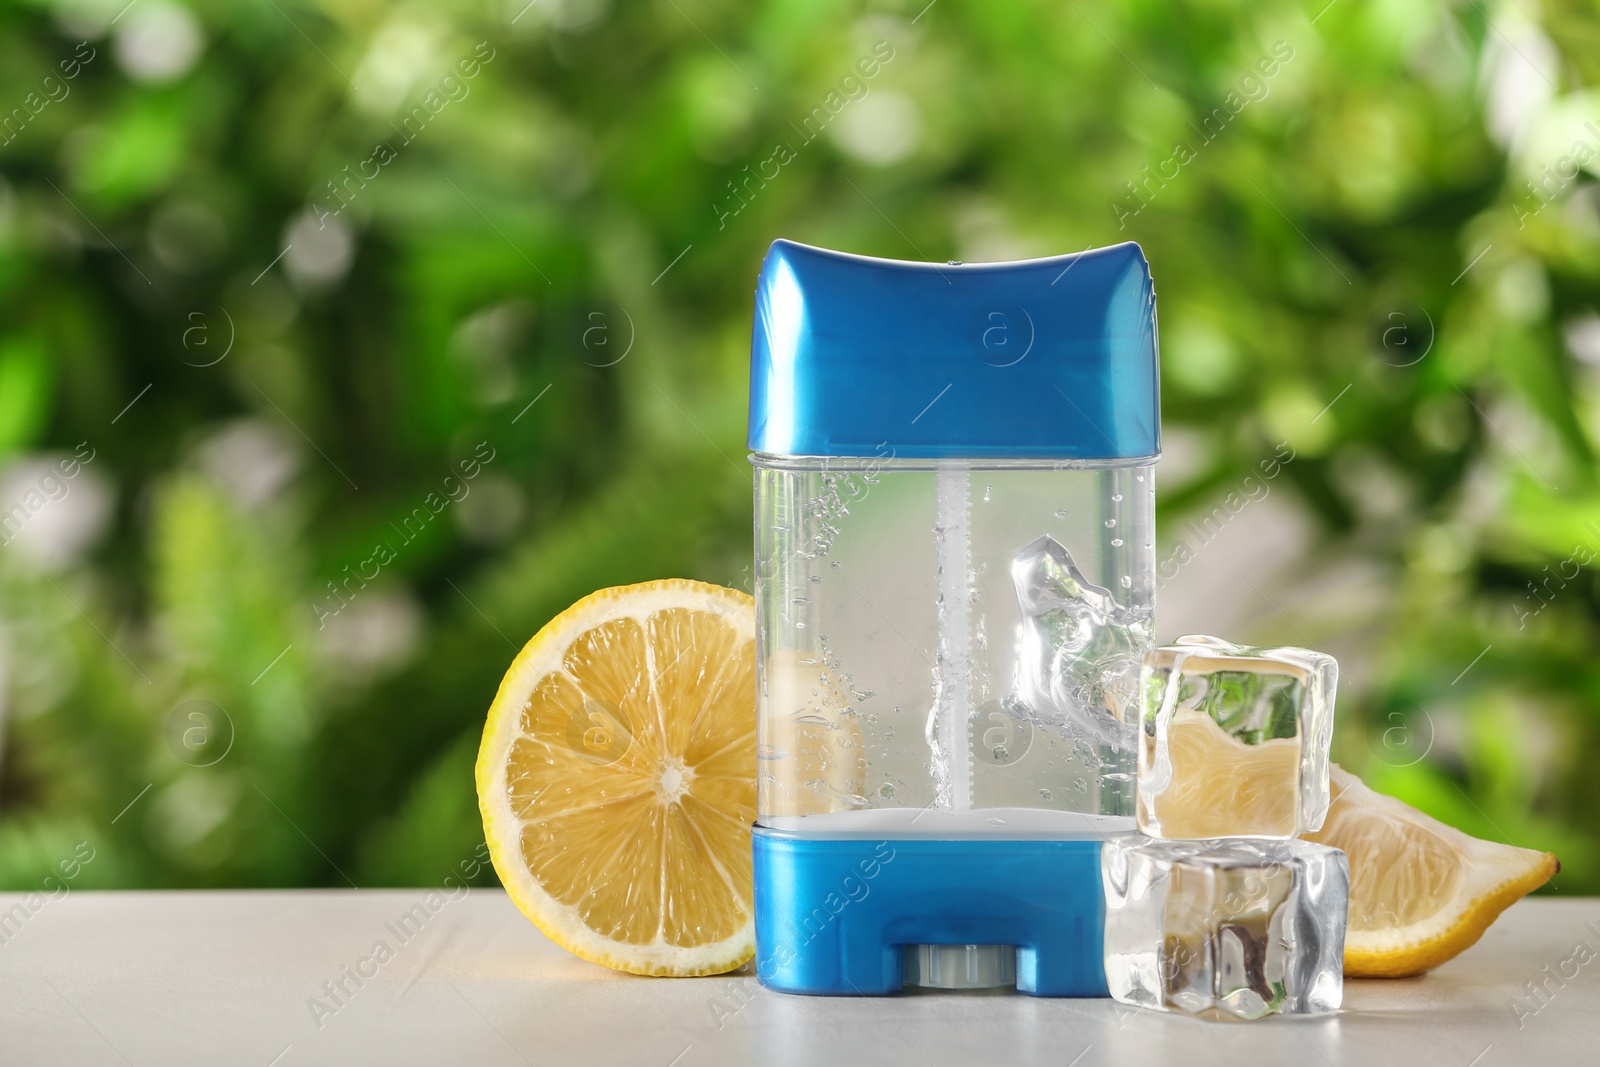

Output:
xmin=1011 ymin=536 xmax=1152 ymax=750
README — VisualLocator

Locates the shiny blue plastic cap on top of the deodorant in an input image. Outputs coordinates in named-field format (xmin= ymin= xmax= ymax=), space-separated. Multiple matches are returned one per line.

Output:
xmin=749 ymin=240 xmax=1160 ymax=459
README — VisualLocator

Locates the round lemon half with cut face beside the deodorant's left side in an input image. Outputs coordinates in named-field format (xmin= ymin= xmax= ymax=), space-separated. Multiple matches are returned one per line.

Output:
xmin=477 ymin=579 xmax=755 ymax=974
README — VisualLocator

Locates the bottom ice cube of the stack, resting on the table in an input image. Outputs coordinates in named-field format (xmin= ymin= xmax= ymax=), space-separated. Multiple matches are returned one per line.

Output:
xmin=1101 ymin=833 xmax=1350 ymax=1019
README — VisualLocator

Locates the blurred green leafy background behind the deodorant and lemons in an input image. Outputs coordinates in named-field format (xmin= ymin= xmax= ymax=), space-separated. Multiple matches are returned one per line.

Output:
xmin=0 ymin=0 xmax=1600 ymax=893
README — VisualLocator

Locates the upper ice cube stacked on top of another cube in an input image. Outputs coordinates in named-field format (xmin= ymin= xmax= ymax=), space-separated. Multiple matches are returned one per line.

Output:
xmin=1138 ymin=637 xmax=1339 ymax=838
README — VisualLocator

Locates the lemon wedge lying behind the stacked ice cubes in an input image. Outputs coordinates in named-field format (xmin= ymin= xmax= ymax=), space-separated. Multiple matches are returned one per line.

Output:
xmin=1306 ymin=766 xmax=1562 ymax=977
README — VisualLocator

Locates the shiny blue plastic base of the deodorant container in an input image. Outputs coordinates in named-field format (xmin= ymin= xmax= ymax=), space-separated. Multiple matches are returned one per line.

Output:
xmin=754 ymin=827 xmax=1107 ymax=997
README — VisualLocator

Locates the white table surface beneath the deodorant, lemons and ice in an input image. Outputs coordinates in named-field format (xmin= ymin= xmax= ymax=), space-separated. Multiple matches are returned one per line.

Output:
xmin=0 ymin=889 xmax=1600 ymax=1067
